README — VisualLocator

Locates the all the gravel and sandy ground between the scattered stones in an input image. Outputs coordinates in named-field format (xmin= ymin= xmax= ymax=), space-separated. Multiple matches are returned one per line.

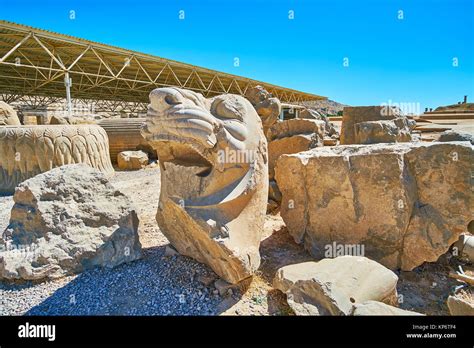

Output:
xmin=0 ymin=167 xmax=472 ymax=315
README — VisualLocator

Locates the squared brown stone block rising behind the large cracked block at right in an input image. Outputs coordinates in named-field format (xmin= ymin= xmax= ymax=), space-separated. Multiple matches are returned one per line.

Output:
xmin=340 ymin=106 xmax=414 ymax=145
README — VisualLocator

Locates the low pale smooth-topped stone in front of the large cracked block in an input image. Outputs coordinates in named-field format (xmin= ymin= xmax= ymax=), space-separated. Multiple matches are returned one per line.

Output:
xmin=273 ymin=256 xmax=398 ymax=315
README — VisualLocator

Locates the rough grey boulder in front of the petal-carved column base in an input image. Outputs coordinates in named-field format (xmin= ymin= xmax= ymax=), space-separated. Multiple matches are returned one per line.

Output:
xmin=0 ymin=164 xmax=141 ymax=280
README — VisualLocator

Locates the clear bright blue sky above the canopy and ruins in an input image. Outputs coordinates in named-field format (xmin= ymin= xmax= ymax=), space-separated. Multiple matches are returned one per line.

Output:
xmin=0 ymin=0 xmax=474 ymax=109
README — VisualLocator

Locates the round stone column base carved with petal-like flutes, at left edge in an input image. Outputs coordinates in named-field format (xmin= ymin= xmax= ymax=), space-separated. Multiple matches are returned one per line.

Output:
xmin=0 ymin=125 xmax=114 ymax=194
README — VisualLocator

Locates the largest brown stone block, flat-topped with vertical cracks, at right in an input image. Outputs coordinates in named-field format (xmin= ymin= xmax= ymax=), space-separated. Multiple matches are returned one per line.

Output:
xmin=276 ymin=142 xmax=474 ymax=270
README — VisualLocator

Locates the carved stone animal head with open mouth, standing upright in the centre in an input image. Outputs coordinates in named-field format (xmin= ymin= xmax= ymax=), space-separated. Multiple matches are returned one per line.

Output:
xmin=142 ymin=88 xmax=268 ymax=283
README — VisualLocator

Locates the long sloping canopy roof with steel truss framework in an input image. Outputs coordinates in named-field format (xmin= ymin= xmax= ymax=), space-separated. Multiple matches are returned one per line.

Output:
xmin=0 ymin=21 xmax=326 ymax=110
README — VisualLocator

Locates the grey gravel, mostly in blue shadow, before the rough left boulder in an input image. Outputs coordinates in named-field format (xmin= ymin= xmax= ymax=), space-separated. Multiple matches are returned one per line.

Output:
xmin=0 ymin=247 xmax=222 ymax=315
